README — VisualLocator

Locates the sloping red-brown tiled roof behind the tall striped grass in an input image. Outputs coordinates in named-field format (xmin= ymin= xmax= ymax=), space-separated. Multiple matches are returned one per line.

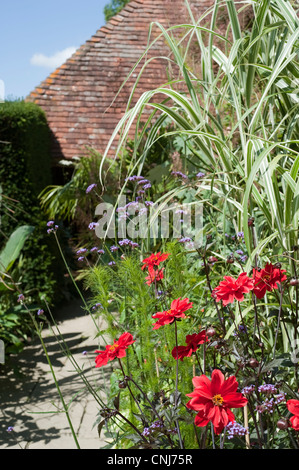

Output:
xmin=27 ymin=0 xmax=232 ymax=161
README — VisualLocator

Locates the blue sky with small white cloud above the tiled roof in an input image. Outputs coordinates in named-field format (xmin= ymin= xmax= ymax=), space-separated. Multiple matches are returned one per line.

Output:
xmin=0 ymin=0 xmax=109 ymax=100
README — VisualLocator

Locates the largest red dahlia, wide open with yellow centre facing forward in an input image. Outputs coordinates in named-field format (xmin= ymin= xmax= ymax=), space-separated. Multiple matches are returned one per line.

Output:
xmin=186 ymin=369 xmax=247 ymax=434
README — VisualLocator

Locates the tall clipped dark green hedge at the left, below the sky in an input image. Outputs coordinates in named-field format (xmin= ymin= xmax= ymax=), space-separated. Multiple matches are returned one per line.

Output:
xmin=0 ymin=101 xmax=63 ymax=303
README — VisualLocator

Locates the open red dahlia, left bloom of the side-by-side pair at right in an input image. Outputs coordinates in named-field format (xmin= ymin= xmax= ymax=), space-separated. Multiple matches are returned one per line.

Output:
xmin=213 ymin=273 xmax=254 ymax=306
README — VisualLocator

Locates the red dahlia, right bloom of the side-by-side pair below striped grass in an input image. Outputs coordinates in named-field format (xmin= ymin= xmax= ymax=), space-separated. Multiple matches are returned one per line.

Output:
xmin=253 ymin=263 xmax=287 ymax=299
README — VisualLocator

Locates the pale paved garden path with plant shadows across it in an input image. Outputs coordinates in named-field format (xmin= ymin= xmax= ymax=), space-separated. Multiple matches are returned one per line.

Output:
xmin=0 ymin=301 xmax=109 ymax=449
